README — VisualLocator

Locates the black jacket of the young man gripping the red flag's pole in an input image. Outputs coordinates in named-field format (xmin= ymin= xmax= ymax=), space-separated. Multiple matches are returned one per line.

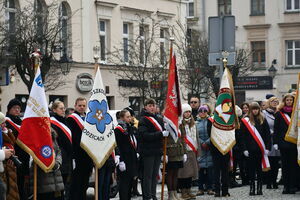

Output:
xmin=138 ymin=110 xmax=164 ymax=156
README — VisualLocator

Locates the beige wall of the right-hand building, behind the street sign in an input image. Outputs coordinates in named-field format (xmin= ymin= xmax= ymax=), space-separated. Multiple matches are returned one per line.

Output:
xmin=190 ymin=0 xmax=300 ymax=100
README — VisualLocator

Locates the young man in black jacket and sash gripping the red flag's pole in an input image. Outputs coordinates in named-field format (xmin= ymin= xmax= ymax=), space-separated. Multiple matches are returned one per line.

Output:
xmin=138 ymin=99 xmax=169 ymax=200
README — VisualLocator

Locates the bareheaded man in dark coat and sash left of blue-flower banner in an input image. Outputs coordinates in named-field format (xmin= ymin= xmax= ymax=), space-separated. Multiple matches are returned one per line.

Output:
xmin=66 ymin=97 xmax=93 ymax=200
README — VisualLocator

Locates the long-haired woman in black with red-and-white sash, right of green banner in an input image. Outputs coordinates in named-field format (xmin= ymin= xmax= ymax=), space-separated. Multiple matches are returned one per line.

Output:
xmin=241 ymin=102 xmax=271 ymax=196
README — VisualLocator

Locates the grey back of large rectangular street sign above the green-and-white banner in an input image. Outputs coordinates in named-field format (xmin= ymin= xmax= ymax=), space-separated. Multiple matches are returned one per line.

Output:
xmin=208 ymin=16 xmax=235 ymax=66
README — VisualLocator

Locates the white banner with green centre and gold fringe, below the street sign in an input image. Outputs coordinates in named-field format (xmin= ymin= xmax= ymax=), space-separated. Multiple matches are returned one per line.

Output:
xmin=211 ymin=67 xmax=237 ymax=155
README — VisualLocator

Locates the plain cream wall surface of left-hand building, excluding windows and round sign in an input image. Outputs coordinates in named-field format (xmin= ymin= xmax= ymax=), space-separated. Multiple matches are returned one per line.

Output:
xmin=0 ymin=0 xmax=186 ymax=112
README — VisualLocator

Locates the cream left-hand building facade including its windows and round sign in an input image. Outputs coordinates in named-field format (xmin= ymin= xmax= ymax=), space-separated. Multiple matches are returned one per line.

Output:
xmin=0 ymin=0 xmax=186 ymax=112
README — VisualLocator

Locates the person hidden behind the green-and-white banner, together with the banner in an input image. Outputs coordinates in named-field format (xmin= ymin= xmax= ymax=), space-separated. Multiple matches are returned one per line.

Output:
xmin=207 ymin=65 xmax=239 ymax=197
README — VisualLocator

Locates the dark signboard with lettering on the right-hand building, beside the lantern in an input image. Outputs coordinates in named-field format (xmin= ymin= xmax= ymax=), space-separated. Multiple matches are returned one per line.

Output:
xmin=234 ymin=76 xmax=273 ymax=90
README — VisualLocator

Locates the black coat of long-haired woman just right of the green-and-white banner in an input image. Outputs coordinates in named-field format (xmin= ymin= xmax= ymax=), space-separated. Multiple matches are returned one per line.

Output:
xmin=240 ymin=119 xmax=271 ymax=152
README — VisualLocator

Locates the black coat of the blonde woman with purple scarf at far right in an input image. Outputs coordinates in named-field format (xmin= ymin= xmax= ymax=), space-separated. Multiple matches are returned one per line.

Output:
xmin=273 ymin=111 xmax=297 ymax=150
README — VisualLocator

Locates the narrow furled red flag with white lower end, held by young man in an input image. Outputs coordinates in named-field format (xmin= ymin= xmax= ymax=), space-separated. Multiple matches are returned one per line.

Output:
xmin=164 ymin=47 xmax=181 ymax=142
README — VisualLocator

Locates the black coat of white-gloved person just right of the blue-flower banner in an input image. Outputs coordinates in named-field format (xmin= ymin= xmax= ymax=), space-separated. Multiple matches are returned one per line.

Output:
xmin=114 ymin=123 xmax=138 ymax=177
